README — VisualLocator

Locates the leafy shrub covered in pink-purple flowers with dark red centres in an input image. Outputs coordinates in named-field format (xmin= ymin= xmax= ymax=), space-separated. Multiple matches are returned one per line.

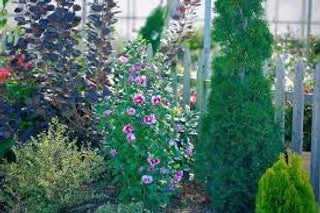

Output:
xmin=97 ymin=41 xmax=193 ymax=207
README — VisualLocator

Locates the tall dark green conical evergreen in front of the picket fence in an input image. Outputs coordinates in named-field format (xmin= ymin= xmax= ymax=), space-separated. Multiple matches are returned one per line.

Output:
xmin=196 ymin=0 xmax=282 ymax=213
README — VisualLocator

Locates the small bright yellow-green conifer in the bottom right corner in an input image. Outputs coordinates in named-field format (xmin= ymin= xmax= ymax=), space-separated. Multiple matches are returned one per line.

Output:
xmin=256 ymin=154 xmax=317 ymax=213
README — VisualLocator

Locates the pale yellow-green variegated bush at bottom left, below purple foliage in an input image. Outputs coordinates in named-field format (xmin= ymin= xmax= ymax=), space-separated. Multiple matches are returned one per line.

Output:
xmin=0 ymin=119 xmax=103 ymax=212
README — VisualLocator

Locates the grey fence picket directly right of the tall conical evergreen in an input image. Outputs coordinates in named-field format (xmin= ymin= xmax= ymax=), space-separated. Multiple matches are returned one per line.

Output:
xmin=275 ymin=56 xmax=285 ymax=144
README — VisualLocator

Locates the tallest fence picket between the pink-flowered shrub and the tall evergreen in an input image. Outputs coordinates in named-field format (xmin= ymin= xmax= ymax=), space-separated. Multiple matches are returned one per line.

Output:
xmin=182 ymin=48 xmax=191 ymax=108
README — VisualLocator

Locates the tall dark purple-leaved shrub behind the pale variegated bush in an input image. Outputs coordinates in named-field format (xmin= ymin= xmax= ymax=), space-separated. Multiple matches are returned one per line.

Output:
xmin=0 ymin=0 xmax=117 ymax=144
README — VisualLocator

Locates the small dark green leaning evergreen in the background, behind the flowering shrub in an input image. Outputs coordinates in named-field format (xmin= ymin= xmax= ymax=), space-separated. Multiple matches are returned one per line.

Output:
xmin=139 ymin=6 xmax=167 ymax=51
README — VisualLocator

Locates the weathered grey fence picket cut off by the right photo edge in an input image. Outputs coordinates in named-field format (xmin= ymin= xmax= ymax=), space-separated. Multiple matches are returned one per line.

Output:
xmin=310 ymin=63 xmax=320 ymax=203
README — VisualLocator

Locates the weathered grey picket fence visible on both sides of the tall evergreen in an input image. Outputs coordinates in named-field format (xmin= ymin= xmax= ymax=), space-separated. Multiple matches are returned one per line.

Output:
xmin=149 ymin=43 xmax=320 ymax=203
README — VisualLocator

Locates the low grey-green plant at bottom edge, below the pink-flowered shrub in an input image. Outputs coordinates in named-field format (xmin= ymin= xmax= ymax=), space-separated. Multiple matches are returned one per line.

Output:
xmin=95 ymin=203 xmax=149 ymax=213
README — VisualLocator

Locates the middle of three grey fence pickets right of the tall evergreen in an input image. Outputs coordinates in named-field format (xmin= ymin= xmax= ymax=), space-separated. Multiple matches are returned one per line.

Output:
xmin=292 ymin=61 xmax=305 ymax=155
